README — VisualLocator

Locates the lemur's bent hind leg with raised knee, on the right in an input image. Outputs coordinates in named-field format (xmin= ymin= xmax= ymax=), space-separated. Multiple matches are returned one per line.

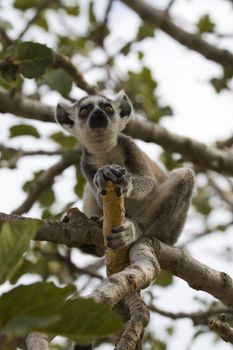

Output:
xmin=135 ymin=168 xmax=194 ymax=245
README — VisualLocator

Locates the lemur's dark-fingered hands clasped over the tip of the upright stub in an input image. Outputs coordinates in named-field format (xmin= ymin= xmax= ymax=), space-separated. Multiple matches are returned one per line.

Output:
xmin=93 ymin=164 xmax=132 ymax=196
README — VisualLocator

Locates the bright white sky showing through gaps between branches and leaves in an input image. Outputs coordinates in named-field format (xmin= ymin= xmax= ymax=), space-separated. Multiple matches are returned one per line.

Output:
xmin=0 ymin=0 xmax=233 ymax=350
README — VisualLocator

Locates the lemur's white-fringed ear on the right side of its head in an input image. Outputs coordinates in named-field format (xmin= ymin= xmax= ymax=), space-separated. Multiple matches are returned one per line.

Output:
xmin=114 ymin=90 xmax=133 ymax=131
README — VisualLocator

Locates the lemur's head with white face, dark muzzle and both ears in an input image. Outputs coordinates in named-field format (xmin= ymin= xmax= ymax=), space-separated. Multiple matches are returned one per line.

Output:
xmin=56 ymin=92 xmax=132 ymax=152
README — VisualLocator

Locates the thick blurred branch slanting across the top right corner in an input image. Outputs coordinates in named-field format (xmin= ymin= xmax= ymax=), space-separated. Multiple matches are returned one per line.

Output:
xmin=121 ymin=0 xmax=233 ymax=69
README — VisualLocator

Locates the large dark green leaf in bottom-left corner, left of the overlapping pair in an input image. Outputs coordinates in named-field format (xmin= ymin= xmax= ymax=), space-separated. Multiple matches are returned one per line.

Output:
xmin=0 ymin=282 xmax=75 ymax=333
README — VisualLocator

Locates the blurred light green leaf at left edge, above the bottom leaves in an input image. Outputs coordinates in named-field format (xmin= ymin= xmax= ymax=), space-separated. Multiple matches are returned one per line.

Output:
xmin=0 ymin=219 xmax=41 ymax=283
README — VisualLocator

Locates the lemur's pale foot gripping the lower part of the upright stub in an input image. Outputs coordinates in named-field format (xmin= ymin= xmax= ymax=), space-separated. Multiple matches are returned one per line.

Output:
xmin=107 ymin=221 xmax=137 ymax=249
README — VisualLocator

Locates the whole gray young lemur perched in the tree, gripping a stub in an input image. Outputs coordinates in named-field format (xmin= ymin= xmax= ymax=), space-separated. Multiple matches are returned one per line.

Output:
xmin=56 ymin=92 xmax=194 ymax=255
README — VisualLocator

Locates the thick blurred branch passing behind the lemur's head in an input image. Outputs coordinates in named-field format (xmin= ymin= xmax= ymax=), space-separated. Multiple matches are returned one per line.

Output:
xmin=0 ymin=87 xmax=233 ymax=176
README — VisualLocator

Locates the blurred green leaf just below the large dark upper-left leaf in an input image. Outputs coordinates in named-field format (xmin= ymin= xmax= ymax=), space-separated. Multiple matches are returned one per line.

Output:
xmin=40 ymin=69 xmax=73 ymax=96
